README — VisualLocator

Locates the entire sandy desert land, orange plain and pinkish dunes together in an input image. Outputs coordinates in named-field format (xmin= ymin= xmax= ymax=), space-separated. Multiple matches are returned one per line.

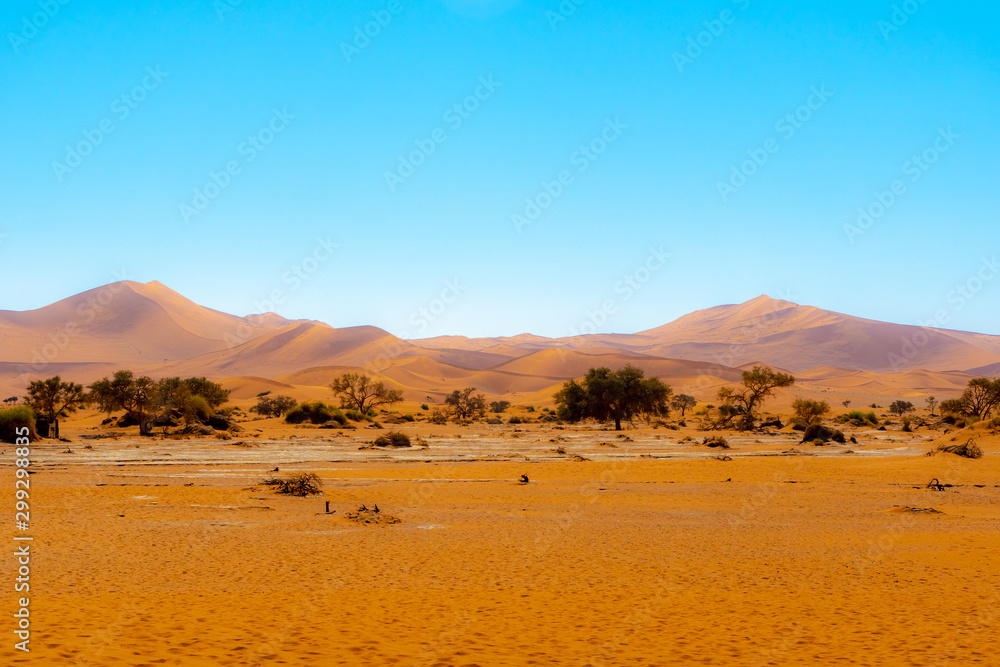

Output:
xmin=0 ymin=283 xmax=1000 ymax=665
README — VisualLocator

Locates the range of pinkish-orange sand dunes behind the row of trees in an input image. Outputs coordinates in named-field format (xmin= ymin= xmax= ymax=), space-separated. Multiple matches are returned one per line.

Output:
xmin=0 ymin=282 xmax=1000 ymax=408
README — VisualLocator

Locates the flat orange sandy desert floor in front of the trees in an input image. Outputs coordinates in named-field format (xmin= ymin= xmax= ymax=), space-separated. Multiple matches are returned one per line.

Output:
xmin=0 ymin=425 xmax=1000 ymax=666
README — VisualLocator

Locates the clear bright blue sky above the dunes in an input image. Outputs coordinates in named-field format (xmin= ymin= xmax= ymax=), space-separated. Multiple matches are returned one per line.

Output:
xmin=0 ymin=0 xmax=1000 ymax=338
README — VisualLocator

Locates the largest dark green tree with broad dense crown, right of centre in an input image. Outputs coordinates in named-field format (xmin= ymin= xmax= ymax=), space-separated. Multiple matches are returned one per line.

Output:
xmin=555 ymin=365 xmax=673 ymax=431
